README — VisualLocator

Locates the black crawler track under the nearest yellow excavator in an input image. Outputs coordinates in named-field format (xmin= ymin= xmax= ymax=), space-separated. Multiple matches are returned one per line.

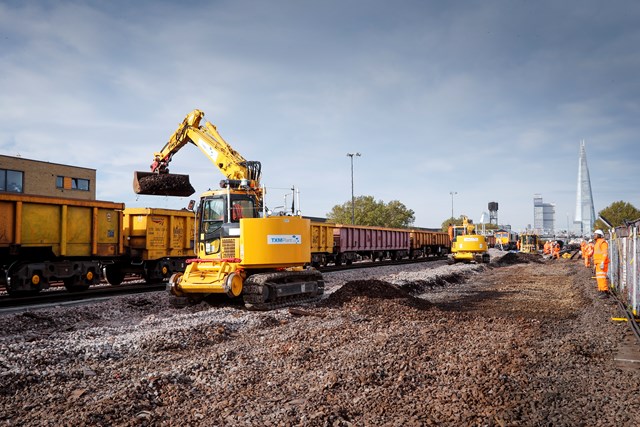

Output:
xmin=242 ymin=270 xmax=324 ymax=310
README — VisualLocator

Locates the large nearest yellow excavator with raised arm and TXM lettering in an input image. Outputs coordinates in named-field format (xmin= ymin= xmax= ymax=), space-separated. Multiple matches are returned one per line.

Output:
xmin=133 ymin=110 xmax=324 ymax=310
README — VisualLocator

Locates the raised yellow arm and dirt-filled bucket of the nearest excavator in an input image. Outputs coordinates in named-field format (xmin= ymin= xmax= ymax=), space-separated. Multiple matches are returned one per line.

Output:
xmin=133 ymin=110 xmax=261 ymax=196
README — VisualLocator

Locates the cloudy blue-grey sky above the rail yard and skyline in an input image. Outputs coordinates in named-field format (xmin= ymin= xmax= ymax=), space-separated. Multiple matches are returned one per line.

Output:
xmin=0 ymin=0 xmax=640 ymax=230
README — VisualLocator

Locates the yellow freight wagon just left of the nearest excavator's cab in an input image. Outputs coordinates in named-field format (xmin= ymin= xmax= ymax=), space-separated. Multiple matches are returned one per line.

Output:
xmin=103 ymin=208 xmax=195 ymax=285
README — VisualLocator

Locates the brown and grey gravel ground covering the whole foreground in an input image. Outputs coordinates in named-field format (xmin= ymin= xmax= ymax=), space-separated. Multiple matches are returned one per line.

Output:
xmin=0 ymin=253 xmax=640 ymax=426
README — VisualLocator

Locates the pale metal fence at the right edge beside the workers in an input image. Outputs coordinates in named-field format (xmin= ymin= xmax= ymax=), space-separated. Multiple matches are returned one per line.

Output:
xmin=609 ymin=221 xmax=640 ymax=316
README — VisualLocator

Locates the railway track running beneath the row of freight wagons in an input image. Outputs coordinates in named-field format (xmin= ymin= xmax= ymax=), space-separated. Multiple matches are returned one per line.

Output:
xmin=0 ymin=257 xmax=447 ymax=313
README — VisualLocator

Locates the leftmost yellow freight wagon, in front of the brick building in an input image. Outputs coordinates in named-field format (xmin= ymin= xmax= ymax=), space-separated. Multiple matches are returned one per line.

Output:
xmin=0 ymin=194 xmax=124 ymax=295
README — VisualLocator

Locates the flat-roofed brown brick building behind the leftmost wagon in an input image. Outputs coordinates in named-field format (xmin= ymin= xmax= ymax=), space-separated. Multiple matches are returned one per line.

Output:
xmin=0 ymin=155 xmax=96 ymax=200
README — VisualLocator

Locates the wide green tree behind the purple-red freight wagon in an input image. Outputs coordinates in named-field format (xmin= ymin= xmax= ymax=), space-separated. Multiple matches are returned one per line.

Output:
xmin=327 ymin=196 xmax=415 ymax=228
